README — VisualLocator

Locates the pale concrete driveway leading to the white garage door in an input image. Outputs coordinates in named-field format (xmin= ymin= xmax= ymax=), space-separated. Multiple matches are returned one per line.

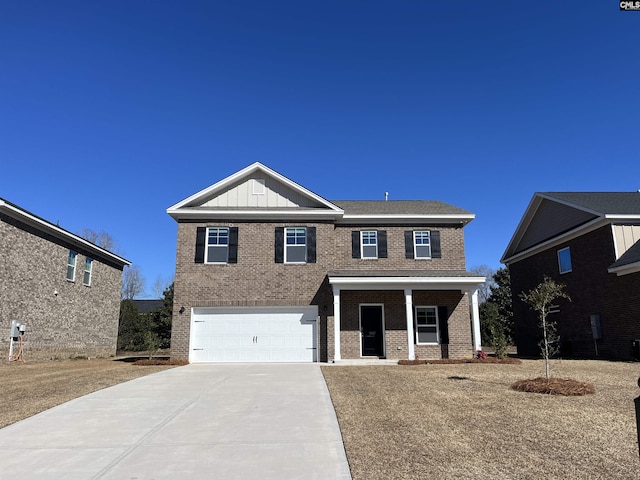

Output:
xmin=0 ymin=364 xmax=351 ymax=480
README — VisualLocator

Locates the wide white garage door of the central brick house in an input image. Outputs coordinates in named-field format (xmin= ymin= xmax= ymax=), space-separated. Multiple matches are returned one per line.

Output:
xmin=189 ymin=307 xmax=318 ymax=363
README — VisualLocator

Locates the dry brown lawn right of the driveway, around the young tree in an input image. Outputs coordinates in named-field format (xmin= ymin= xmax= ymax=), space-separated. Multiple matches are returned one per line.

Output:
xmin=322 ymin=360 xmax=640 ymax=480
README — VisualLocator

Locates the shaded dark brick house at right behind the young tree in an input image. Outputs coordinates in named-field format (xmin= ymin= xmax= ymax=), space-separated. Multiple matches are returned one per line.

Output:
xmin=501 ymin=192 xmax=640 ymax=359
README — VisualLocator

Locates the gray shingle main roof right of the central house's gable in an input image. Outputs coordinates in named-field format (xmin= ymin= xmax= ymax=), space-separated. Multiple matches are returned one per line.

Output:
xmin=330 ymin=200 xmax=472 ymax=215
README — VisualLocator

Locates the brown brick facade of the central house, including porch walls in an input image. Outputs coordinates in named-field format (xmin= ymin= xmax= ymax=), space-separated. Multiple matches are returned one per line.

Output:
xmin=172 ymin=220 xmax=473 ymax=362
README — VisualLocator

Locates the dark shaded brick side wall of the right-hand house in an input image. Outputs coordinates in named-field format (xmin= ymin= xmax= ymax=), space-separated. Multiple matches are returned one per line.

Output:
xmin=509 ymin=226 xmax=640 ymax=359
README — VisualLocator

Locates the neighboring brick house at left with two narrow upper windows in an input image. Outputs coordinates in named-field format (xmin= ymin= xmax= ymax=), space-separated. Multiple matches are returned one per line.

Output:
xmin=0 ymin=199 xmax=130 ymax=359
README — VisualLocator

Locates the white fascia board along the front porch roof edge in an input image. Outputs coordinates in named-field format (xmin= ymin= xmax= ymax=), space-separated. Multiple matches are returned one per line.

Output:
xmin=329 ymin=277 xmax=487 ymax=291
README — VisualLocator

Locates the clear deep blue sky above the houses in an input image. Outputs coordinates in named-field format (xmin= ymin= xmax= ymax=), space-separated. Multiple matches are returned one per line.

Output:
xmin=0 ymin=0 xmax=640 ymax=295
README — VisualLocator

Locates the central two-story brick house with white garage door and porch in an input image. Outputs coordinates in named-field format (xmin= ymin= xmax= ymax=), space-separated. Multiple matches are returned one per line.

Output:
xmin=167 ymin=163 xmax=485 ymax=362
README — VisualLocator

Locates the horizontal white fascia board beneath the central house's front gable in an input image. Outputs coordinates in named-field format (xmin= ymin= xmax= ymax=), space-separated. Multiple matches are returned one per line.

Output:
xmin=167 ymin=208 xmax=342 ymax=220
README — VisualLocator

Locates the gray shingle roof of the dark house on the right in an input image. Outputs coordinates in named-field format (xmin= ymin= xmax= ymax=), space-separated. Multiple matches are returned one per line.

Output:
xmin=541 ymin=192 xmax=640 ymax=215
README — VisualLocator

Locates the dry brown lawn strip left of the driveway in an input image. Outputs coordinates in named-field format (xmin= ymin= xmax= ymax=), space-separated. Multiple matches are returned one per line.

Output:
xmin=0 ymin=359 xmax=180 ymax=430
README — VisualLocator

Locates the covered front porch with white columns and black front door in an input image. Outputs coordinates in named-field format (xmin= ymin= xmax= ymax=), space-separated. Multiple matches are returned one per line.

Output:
xmin=327 ymin=271 xmax=485 ymax=362
